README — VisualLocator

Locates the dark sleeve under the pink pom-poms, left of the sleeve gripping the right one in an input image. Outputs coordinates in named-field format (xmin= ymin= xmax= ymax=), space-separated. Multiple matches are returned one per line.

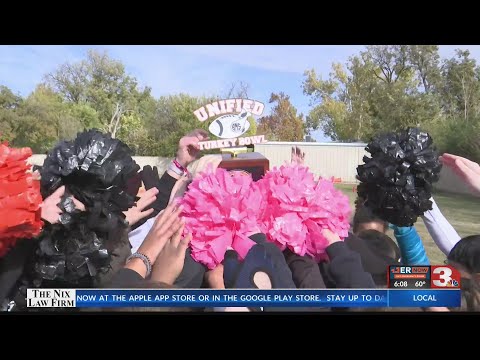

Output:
xmin=283 ymin=250 xmax=326 ymax=289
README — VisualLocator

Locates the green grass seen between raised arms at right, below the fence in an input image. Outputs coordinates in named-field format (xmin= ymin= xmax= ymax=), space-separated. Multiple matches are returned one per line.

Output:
xmin=336 ymin=184 xmax=480 ymax=265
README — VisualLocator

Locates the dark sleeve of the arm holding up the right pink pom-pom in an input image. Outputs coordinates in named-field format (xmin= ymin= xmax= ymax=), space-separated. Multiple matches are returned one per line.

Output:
xmin=326 ymin=241 xmax=376 ymax=289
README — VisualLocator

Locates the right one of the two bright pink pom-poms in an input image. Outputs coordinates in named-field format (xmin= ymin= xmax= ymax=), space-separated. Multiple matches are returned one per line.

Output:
xmin=254 ymin=164 xmax=351 ymax=261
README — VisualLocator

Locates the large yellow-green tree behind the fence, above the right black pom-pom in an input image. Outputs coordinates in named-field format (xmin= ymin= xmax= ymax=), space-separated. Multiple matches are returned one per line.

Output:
xmin=303 ymin=45 xmax=441 ymax=141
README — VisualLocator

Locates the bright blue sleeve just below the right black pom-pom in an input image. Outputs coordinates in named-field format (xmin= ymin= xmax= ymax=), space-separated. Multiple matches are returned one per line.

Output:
xmin=393 ymin=226 xmax=430 ymax=265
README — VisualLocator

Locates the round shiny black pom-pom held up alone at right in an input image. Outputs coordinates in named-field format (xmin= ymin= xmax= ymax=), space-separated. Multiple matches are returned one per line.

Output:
xmin=357 ymin=128 xmax=442 ymax=226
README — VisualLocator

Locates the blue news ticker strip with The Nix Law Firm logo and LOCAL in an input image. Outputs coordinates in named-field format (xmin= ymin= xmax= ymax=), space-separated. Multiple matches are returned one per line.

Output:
xmin=27 ymin=289 xmax=461 ymax=308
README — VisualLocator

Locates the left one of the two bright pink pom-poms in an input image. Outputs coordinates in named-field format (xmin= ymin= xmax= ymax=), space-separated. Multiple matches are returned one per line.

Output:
xmin=180 ymin=168 xmax=262 ymax=269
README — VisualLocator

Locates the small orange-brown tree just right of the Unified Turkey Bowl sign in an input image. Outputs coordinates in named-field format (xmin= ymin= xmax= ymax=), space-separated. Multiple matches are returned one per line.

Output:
xmin=258 ymin=92 xmax=305 ymax=141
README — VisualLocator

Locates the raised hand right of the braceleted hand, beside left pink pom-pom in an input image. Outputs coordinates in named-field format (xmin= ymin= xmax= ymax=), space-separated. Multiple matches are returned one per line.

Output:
xmin=151 ymin=225 xmax=192 ymax=285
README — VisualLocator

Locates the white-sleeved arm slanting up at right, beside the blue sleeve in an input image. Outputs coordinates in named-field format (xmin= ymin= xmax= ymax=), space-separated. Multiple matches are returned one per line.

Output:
xmin=422 ymin=198 xmax=461 ymax=256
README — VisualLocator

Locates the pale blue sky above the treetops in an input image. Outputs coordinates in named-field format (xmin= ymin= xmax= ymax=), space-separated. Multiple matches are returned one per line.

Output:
xmin=0 ymin=45 xmax=480 ymax=141
